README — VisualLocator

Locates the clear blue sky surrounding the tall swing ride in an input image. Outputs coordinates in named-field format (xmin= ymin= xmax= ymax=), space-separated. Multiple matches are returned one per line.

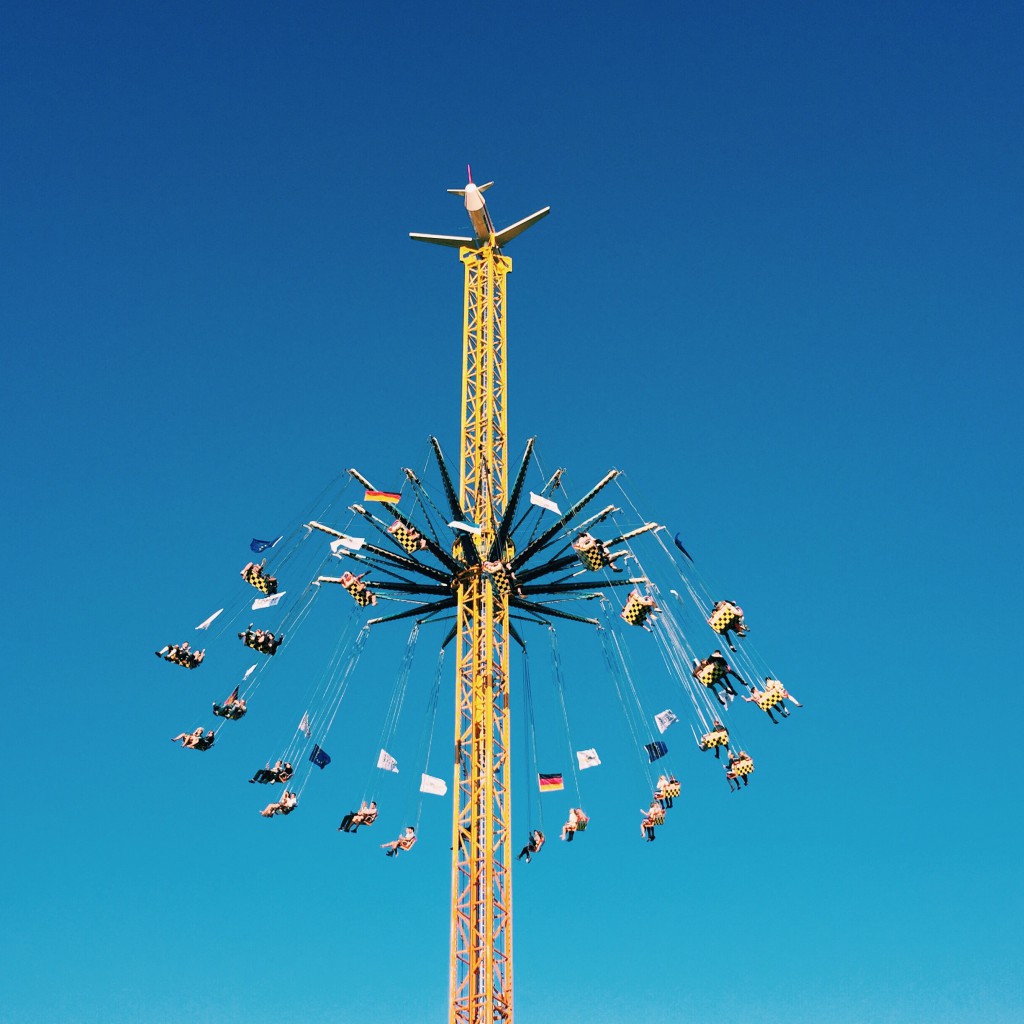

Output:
xmin=0 ymin=2 xmax=1024 ymax=1024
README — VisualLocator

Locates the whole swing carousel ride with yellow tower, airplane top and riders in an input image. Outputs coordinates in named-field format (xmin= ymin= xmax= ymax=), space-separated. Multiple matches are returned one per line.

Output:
xmin=157 ymin=174 xmax=800 ymax=1024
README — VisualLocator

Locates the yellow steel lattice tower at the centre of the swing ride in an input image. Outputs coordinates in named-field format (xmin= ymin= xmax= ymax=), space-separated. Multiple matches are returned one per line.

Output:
xmin=449 ymin=245 xmax=512 ymax=1024
